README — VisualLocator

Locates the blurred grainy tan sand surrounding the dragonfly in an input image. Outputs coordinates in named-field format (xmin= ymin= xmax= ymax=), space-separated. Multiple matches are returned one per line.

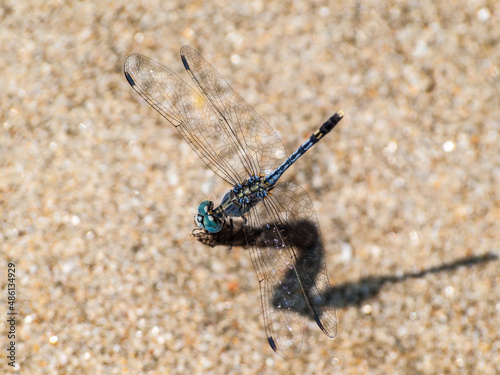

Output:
xmin=0 ymin=0 xmax=500 ymax=374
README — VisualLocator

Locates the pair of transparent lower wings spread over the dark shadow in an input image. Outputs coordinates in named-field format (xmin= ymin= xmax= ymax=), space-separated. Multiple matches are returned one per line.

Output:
xmin=245 ymin=183 xmax=337 ymax=358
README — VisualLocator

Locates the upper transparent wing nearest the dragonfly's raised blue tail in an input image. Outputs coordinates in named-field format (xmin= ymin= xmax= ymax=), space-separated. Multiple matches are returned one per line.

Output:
xmin=181 ymin=46 xmax=287 ymax=179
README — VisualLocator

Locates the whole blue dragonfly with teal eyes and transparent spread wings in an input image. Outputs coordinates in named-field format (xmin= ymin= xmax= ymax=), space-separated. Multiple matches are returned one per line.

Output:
xmin=124 ymin=46 xmax=344 ymax=358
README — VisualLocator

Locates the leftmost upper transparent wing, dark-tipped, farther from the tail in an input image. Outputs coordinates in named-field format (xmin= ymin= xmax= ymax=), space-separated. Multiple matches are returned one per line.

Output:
xmin=124 ymin=54 xmax=246 ymax=185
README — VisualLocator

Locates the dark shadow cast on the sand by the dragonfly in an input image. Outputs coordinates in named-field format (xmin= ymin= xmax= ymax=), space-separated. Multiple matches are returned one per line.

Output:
xmin=195 ymin=220 xmax=498 ymax=319
